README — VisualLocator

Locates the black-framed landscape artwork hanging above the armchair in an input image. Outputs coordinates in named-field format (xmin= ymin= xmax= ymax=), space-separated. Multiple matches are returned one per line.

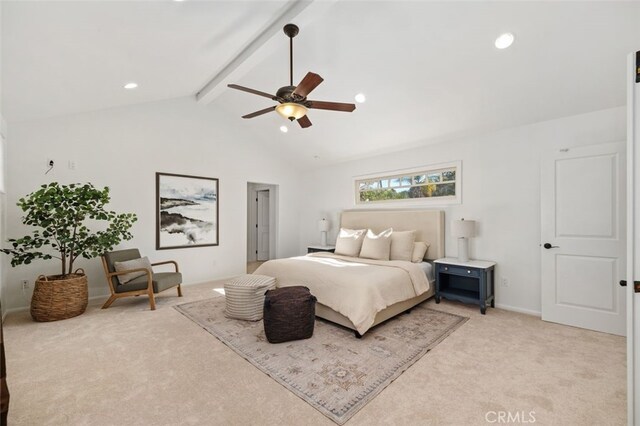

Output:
xmin=156 ymin=173 xmax=220 ymax=250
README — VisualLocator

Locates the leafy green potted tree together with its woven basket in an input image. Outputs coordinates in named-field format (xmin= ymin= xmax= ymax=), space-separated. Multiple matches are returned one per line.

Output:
xmin=0 ymin=182 xmax=137 ymax=321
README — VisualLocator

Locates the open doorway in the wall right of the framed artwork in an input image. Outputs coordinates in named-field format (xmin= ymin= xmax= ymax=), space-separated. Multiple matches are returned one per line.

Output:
xmin=247 ymin=182 xmax=278 ymax=273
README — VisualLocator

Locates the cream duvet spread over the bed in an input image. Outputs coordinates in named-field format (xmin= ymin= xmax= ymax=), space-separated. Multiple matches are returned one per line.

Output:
xmin=255 ymin=252 xmax=429 ymax=334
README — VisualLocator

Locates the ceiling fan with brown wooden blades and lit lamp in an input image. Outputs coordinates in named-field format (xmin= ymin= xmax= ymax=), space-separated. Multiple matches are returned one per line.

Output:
xmin=228 ymin=24 xmax=356 ymax=128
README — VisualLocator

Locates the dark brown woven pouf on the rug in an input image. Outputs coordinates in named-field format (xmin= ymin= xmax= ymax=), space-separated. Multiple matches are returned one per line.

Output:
xmin=263 ymin=286 xmax=316 ymax=343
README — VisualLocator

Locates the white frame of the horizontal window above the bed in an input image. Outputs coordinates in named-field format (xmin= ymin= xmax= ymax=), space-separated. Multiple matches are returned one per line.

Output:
xmin=353 ymin=161 xmax=462 ymax=207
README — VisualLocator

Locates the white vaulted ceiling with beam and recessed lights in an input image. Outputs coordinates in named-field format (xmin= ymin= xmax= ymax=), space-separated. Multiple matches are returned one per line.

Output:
xmin=2 ymin=0 xmax=640 ymax=165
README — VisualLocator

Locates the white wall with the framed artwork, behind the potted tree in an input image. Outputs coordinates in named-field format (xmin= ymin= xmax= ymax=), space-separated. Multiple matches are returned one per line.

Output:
xmin=5 ymin=98 xmax=299 ymax=308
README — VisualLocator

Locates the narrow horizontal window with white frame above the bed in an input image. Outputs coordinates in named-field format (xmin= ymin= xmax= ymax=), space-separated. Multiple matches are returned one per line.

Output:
xmin=355 ymin=161 xmax=461 ymax=204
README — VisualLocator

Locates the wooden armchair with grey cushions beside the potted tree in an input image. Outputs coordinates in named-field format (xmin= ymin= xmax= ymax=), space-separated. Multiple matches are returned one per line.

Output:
xmin=102 ymin=249 xmax=182 ymax=311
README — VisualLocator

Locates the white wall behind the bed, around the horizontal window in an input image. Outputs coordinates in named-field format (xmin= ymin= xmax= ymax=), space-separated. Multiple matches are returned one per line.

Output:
xmin=300 ymin=107 xmax=626 ymax=314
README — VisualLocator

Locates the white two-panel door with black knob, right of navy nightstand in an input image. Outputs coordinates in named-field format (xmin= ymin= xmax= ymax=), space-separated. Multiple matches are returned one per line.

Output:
xmin=541 ymin=142 xmax=626 ymax=335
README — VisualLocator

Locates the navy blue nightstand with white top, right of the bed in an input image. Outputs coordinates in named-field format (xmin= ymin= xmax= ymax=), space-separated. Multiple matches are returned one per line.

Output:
xmin=433 ymin=258 xmax=496 ymax=315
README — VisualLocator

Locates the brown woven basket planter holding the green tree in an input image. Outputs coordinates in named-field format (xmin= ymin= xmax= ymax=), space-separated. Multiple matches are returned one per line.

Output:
xmin=31 ymin=269 xmax=89 ymax=322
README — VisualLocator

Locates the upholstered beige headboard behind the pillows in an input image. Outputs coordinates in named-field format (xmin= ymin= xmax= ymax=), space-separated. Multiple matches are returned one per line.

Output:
xmin=340 ymin=210 xmax=444 ymax=260
